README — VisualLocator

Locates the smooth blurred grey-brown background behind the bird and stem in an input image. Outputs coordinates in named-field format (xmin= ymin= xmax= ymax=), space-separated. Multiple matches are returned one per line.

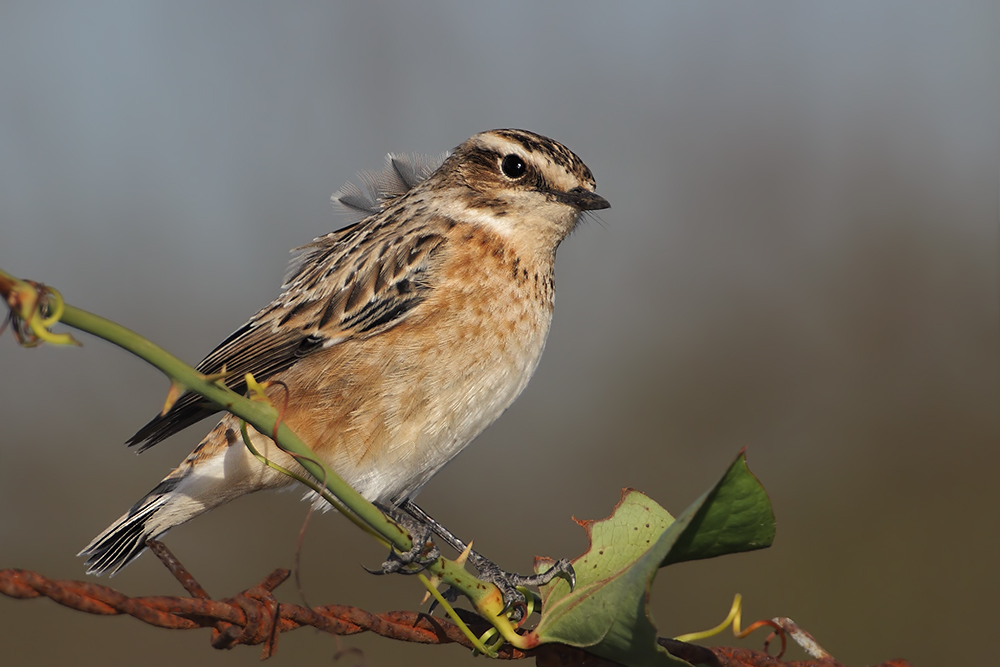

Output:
xmin=0 ymin=0 xmax=1000 ymax=667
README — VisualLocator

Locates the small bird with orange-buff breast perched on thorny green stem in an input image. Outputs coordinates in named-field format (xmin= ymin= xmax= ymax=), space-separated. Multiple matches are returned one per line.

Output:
xmin=79 ymin=129 xmax=610 ymax=594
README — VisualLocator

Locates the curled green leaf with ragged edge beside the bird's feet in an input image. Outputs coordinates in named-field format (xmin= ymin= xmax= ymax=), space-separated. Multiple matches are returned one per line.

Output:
xmin=532 ymin=452 xmax=774 ymax=667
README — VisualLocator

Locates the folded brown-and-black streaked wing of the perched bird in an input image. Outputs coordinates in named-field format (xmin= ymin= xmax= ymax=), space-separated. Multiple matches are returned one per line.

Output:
xmin=127 ymin=218 xmax=444 ymax=451
